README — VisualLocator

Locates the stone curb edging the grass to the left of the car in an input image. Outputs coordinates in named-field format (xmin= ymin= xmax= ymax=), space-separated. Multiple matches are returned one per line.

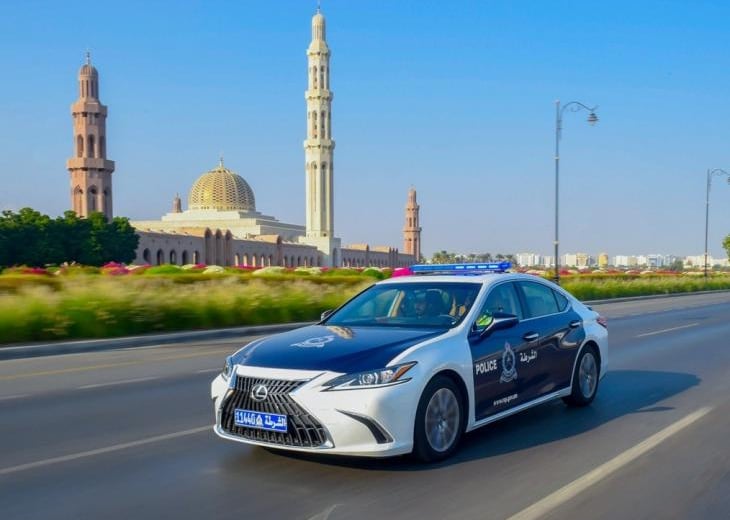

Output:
xmin=0 ymin=322 xmax=313 ymax=361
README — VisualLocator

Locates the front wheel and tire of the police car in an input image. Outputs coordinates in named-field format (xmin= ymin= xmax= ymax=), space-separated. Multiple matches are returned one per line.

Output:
xmin=413 ymin=376 xmax=465 ymax=462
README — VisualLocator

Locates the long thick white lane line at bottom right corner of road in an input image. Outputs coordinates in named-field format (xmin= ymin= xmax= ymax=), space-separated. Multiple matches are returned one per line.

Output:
xmin=508 ymin=407 xmax=712 ymax=520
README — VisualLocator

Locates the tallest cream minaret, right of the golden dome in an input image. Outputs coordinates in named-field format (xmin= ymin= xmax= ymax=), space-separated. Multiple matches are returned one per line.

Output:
xmin=303 ymin=8 xmax=339 ymax=265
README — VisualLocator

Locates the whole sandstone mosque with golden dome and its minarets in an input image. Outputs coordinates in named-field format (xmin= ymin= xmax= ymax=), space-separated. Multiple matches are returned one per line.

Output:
xmin=67 ymin=9 xmax=421 ymax=267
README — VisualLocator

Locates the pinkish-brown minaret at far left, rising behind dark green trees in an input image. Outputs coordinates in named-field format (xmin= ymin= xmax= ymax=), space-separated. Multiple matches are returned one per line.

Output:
xmin=66 ymin=52 xmax=114 ymax=220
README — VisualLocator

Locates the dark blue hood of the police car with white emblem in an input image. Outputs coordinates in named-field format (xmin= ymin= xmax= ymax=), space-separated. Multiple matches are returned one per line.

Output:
xmin=233 ymin=325 xmax=446 ymax=373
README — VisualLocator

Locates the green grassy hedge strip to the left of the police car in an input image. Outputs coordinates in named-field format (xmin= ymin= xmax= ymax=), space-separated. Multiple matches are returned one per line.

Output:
xmin=0 ymin=276 xmax=373 ymax=343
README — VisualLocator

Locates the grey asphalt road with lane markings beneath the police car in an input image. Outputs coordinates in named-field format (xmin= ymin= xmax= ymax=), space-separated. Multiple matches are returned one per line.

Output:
xmin=0 ymin=293 xmax=730 ymax=520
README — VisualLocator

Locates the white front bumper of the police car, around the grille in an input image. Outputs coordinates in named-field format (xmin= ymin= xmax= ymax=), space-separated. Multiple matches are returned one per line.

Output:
xmin=211 ymin=366 xmax=421 ymax=457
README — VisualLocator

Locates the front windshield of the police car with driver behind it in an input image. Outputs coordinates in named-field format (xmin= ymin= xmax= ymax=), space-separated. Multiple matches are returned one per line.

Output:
xmin=325 ymin=281 xmax=481 ymax=327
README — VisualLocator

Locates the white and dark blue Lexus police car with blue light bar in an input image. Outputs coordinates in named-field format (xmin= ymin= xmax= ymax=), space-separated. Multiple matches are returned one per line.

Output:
xmin=211 ymin=263 xmax=608 ymax=461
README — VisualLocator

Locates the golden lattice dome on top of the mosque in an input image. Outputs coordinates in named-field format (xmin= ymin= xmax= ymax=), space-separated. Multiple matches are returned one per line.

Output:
xmin=188 ymin=160 xmax=256 ymax=211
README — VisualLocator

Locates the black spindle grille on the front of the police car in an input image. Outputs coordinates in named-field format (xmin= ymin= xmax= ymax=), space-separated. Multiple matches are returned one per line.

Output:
xmin=221 ymin=376 xmax=327 ymax=448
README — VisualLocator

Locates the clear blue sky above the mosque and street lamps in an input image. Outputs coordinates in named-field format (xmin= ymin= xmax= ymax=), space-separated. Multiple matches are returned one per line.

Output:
xmin=0 ymin=0 xmax=730 ymax=257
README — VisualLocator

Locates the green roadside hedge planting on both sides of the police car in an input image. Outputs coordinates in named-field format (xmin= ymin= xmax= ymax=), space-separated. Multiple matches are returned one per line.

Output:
xmin=0 ymin=266 xmax=730 ymax=344
